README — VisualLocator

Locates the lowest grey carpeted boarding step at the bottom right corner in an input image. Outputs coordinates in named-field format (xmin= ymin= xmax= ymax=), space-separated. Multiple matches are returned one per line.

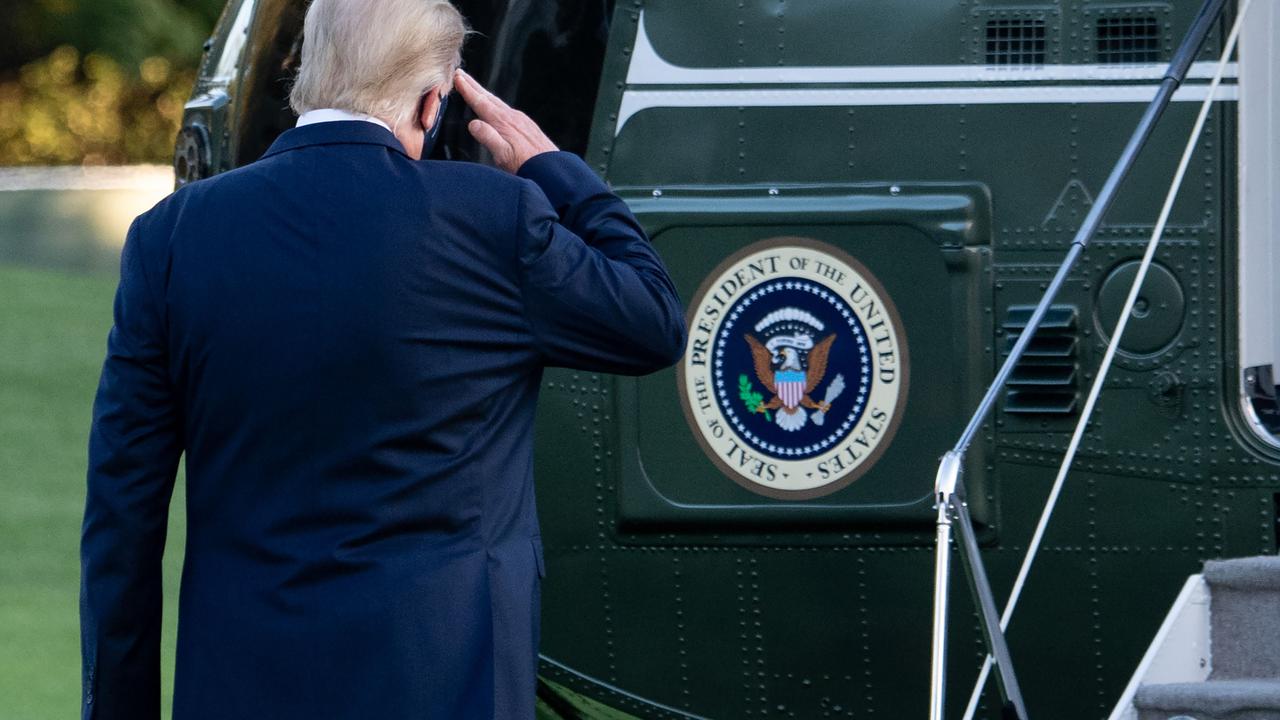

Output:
xmin=1133 ymin=679 xmax=1280 ymax=720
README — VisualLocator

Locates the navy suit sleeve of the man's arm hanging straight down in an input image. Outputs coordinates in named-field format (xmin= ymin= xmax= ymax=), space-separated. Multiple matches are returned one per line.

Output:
xmin=81 ymin=220 xmax=182 ymax=720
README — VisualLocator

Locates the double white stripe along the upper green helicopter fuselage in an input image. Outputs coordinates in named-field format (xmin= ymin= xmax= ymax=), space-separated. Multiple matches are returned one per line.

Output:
xmin=614 ymin=12 xmax=1238 ymax=135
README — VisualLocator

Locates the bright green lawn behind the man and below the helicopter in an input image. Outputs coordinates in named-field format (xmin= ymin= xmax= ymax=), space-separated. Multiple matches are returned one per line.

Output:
xmin=0 ymin=260 xmax=630 ymax=720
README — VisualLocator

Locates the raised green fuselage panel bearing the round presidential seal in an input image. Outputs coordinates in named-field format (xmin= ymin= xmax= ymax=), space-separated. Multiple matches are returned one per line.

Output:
xmin=604 ymin=183 xmax=995 ymax=542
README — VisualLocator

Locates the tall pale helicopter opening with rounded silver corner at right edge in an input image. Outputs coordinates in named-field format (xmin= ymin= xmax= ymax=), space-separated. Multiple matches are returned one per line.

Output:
xmin=1236 ymin=3 xmax=1280 ymax=446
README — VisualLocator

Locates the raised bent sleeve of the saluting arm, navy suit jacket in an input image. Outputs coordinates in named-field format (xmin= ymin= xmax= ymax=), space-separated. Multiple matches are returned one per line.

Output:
xmin=517 ymin=152 xmax=686 ymax=374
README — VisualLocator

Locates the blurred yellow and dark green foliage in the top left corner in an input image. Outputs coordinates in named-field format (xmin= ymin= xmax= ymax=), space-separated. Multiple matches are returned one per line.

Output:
xmin=0 ymin=0 xmax=225 ymax=165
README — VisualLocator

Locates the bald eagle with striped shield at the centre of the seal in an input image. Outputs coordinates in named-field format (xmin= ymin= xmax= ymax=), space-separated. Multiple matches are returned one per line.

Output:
xmin=742 ymin=307 xmax=845 ymax=432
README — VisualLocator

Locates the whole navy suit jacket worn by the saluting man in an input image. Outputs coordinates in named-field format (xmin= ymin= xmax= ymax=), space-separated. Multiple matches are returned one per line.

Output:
xmin=81 ymin=122 xmax=686 ymax=720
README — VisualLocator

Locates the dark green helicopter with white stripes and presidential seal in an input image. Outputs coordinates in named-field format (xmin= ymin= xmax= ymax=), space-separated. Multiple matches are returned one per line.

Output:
xmin=174 ymin=0 xmax=1280 ymax=719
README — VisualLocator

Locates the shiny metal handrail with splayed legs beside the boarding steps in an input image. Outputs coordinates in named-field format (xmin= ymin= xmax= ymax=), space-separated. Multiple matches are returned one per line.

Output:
xmin=929 ymin=0 xmax=1226 ymax=720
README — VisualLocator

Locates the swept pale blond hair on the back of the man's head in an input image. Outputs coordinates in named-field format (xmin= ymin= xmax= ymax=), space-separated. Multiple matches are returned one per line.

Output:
xmin=289 ymin=0 xmax=468 ymax=128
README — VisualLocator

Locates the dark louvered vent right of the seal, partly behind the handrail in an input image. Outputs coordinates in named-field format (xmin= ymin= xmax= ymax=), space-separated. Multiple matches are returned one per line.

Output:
xmin=1004 ymin=305 xmax=1079 ymax=415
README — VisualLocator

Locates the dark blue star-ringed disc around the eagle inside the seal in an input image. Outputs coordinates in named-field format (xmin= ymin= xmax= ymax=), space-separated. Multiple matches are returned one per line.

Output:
xmin=712 ymin=278 xmax=874 ymax=460
